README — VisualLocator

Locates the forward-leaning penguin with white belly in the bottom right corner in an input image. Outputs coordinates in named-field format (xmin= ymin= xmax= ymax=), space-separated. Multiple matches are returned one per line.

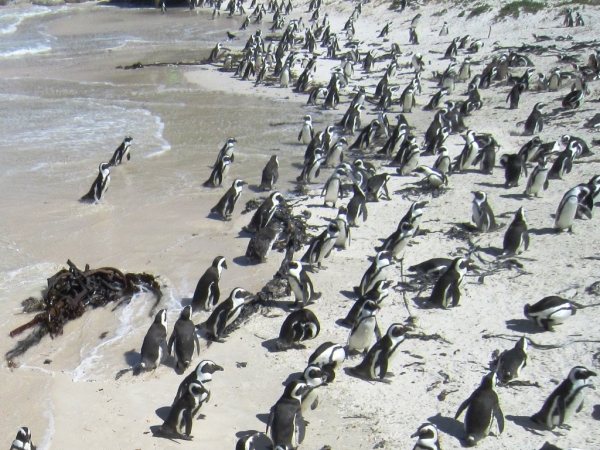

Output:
xmin=531 ymin=366 xmax=596 ymax=430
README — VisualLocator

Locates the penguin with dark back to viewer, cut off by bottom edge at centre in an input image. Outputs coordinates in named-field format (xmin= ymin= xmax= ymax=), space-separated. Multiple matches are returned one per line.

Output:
xmin=266 ymin=380 xmax=310 ymax=449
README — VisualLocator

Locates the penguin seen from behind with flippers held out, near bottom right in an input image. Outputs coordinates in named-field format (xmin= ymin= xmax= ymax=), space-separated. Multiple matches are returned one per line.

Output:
xmin=454 ymin=372 xmax=504 ymax=447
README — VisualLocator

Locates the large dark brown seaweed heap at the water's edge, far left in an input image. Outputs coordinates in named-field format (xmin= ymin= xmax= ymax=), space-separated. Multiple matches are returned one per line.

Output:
xmin=5 ymin=260 xmax=162 ymax=366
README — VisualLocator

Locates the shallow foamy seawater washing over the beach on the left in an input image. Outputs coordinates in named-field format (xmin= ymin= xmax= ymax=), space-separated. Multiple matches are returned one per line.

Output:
xmin=0 ymin=1 xmax=318 ymax=380
